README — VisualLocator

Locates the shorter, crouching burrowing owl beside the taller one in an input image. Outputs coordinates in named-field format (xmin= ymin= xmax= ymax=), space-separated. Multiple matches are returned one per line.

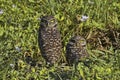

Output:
xmin=66 ymin=36 xmax=88 ymax=64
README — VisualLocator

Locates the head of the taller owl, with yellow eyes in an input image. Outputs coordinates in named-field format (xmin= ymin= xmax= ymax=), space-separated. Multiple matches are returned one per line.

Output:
xmin=40 ymin=16 xmax=57 ymax=28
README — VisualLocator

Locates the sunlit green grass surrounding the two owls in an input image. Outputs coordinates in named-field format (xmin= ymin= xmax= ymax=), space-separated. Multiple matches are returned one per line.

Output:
xmin=0 ymin=0 xmax=120 ymax=80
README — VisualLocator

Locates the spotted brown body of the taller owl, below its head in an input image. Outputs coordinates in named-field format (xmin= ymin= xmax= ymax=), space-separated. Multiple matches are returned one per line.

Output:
xmin=39 ymin=28 xmax=62 ymax=63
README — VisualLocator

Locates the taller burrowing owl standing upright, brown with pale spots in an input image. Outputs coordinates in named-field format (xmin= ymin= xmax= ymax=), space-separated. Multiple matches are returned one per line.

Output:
xmin=38 ymin=16 xmax=62 ymax=64
